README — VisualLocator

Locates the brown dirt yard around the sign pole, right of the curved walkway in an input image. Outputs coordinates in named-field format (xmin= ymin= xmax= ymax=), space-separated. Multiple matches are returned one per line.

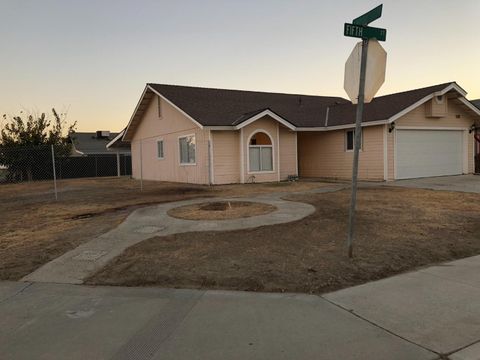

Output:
xmin=88 ymin=187 xmax=480 ymax=293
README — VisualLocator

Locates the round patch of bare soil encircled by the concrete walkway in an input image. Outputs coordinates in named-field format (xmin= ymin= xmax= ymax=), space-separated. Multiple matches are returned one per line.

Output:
xmin=167 ymin=201 xmax=277 ymax=220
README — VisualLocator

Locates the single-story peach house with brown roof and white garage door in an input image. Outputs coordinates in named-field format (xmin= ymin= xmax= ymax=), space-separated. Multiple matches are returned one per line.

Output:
xmin=123 ymin=82 xmax=480 ymax=184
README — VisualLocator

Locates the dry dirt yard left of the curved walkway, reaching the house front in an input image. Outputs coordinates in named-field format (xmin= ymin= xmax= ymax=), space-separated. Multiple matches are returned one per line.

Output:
xmin=0 ymin=178 xmax=325 ymax=280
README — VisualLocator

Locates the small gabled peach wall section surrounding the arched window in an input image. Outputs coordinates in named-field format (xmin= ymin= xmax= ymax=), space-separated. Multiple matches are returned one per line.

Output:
xmin=240 ymin=116 xmax=280 ymax=183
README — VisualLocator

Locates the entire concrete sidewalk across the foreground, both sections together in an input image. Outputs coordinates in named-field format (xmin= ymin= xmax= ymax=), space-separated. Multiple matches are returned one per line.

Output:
xmin=0 ymin=256 xmax=480 ymax=360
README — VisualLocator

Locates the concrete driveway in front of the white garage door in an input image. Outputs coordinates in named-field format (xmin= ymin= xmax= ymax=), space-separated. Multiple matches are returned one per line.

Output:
xmin=386 ymin=175 xmax=480 ymax=193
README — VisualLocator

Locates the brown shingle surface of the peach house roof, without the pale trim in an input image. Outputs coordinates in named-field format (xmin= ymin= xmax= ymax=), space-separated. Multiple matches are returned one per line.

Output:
xmin=148 ymin=82 xmax=452 ymax=127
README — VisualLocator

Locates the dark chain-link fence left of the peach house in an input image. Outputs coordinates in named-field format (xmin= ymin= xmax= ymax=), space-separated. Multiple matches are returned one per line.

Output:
xmin=0 ymin=145 xmax=132 ymax=198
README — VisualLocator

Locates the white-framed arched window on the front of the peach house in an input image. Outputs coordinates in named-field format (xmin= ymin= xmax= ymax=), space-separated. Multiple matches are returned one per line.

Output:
xmin=248 ymin=132 xmax=273 ymax=172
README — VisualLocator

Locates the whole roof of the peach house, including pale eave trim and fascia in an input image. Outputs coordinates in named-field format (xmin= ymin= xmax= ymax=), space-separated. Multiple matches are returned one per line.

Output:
xmin=124 ymin=82 xmax=480 ymax=141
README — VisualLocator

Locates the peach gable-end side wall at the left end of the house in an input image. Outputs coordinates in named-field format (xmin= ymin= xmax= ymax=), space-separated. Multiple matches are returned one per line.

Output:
xmin=132 ymin=97 xmax=209 ymax=184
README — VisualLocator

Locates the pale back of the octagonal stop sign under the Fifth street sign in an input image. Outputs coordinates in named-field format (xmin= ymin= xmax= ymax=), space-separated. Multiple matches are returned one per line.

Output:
xmin=343 ymin=40 xmax=387 ymax=104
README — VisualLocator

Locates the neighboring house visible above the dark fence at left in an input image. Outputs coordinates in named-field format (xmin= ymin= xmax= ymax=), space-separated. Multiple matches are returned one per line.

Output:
xmin=70 ymin=132 xmax=130 ymax=155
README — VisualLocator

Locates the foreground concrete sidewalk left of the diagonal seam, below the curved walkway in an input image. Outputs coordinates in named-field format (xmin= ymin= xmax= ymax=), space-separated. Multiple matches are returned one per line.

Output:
xmin=0 ymin=282 xmax=438 ymax=360
